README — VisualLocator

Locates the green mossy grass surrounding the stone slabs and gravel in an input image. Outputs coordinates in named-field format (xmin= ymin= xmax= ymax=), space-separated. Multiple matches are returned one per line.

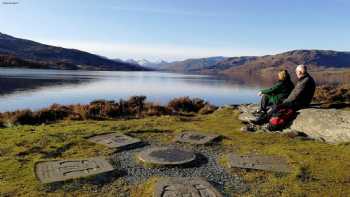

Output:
xmin=0 ymin=109 xmax=350 ymax=196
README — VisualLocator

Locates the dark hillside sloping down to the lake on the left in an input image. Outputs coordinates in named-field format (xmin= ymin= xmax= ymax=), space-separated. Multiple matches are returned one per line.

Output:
xmin=0 ymin=33 xmax=149 ymax=71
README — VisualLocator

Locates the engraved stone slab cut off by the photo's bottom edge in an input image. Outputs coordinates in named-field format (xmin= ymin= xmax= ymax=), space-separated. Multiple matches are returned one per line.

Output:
xmin=154 ymin=177 xmax=222 ymax=197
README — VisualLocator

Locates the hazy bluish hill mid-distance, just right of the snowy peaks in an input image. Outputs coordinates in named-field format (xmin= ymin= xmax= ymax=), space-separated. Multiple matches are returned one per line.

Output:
xmin=160 ymin=57 xmax=226 ymax=72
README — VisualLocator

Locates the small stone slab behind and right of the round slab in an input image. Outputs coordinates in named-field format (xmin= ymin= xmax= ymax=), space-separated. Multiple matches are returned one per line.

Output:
xmin=176 ymin=132 xmax=220 ymax=144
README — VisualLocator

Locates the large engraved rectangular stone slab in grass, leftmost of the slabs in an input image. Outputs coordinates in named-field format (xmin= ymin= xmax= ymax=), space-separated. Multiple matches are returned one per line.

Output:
xmin=34 ymin=157 xmax=113 ymax=183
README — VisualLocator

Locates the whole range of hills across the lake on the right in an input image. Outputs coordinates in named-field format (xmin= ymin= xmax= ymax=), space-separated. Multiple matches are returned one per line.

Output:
xmin=161 ymin=50 xmax=350 ymax=76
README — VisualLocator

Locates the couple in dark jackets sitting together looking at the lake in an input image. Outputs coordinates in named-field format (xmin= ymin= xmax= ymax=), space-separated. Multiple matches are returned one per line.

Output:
xmin=253 ymin=65 xmax=316 ymax=124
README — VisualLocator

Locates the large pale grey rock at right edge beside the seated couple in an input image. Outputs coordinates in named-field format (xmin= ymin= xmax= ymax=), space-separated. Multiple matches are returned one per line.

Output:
xmin=291 ymin=109 xmax=350 ymax=143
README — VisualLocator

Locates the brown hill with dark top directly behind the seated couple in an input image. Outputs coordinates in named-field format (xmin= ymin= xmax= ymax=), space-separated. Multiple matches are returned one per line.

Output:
xmin=215 ymin=50 xmax=350 ymax=83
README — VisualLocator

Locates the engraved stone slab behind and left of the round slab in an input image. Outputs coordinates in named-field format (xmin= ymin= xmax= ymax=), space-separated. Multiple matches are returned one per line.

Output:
xmin=88 ymin=133 xmax=141 ymax=148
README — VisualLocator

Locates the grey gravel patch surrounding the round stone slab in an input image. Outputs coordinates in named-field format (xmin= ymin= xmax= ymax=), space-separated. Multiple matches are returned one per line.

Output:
xmin=111 ymin=143 xmax=245 ymax=196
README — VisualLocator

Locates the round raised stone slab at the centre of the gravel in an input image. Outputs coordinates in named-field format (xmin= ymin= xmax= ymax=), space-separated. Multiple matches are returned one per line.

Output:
xmin=138 ymin=147 xmax=196 ymax=165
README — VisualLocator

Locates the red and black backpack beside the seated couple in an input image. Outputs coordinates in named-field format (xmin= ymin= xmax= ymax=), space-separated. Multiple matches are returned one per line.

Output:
xmin=268 ymin=108 xmax=296 ymax=131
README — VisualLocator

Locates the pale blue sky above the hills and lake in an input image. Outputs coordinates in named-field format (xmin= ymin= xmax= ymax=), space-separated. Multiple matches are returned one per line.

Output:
xmin=0 ymin=0 xmax=350 ymax=60
